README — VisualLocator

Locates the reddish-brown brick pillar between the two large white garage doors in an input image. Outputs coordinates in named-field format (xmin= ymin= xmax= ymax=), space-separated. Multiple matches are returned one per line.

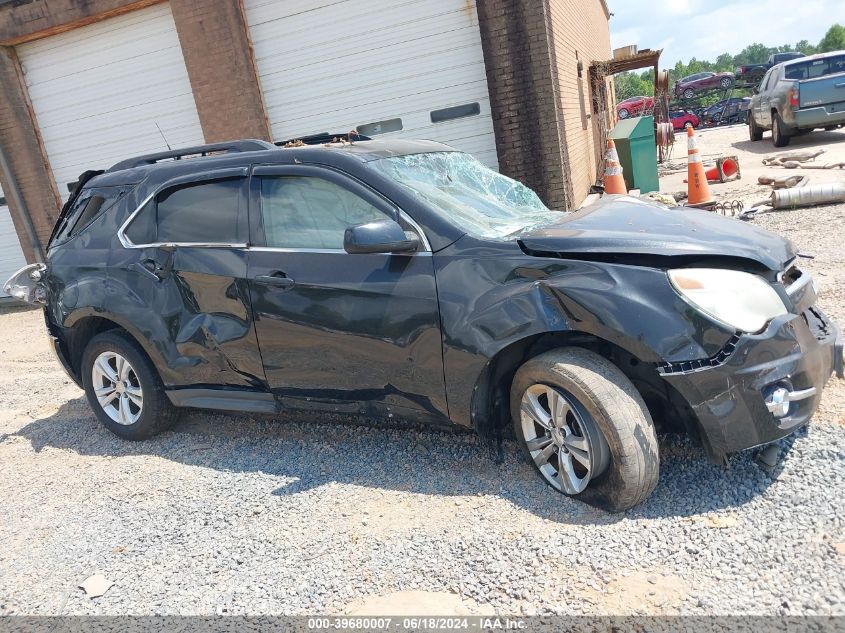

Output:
xmin=170 ymin=0 xmax=271 ymax=143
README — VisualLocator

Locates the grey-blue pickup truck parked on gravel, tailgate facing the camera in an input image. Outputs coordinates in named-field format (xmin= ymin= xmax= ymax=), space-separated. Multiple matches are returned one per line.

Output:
xmin=748 ymin=51 xmax=845 ymax=147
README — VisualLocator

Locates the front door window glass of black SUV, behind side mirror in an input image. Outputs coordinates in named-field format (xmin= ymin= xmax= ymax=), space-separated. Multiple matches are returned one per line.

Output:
xmin=261 ymin=176 xmax=388 ymax=249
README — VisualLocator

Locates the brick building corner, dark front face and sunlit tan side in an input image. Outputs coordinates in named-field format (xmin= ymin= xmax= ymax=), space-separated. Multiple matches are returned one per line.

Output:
xmin=477 ymin=0 xmax=611 ymax=208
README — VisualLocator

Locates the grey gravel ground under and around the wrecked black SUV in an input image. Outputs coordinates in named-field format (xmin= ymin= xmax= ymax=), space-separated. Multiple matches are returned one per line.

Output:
xmin=0 ymin=124 xmax=845 ymax=615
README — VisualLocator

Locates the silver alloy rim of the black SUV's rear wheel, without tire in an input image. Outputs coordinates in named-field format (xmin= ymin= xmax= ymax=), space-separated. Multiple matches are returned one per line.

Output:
xmin=91 ymin=352 xmax=144 ymax=426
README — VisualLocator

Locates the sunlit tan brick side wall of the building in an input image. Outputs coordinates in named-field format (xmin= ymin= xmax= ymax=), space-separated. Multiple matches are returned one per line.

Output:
xmin=547 ymin=0 xmax=612 ymax=205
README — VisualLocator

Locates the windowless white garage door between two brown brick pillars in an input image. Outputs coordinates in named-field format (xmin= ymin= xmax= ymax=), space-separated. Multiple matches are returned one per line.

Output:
xmin=17 ymin=3 xmax=203 ymax=198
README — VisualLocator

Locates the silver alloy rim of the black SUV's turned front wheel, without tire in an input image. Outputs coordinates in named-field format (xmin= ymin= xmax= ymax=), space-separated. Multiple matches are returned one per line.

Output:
xmin=520 ymin=384 xmax=610 ymax=495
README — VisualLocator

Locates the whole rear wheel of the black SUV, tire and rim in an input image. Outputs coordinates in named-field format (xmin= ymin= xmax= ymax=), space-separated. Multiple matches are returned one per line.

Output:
xmin=81 ymin=330 xmax=178 ymax=441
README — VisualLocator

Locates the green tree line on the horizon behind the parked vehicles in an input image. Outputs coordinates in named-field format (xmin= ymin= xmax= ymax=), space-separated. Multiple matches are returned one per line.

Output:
xmin=613 ymin=24 xmax=845 ymax=105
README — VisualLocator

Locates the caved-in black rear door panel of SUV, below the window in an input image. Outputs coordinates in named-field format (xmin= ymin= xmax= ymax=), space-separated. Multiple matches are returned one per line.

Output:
xmin=105 ymin=246 xmax=266 ymax=389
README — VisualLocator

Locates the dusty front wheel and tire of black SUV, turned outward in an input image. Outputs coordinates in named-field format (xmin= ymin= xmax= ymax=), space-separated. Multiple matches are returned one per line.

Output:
xmin=510 ymin=348 xmax=660 ymax=512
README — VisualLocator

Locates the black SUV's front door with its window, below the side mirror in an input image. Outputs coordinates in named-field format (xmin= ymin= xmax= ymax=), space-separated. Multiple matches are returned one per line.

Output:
xmin=248 ymin=165 xmax=447 ymax=415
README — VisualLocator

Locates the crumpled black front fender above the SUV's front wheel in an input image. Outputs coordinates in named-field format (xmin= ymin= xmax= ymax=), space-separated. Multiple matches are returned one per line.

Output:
xmin=434 ymin=238 xmax=733 ymax=426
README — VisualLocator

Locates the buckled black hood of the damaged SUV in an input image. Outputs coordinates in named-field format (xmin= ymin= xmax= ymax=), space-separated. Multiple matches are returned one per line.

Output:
xmin=519 ymin=196 xmax=796 ymax=271
